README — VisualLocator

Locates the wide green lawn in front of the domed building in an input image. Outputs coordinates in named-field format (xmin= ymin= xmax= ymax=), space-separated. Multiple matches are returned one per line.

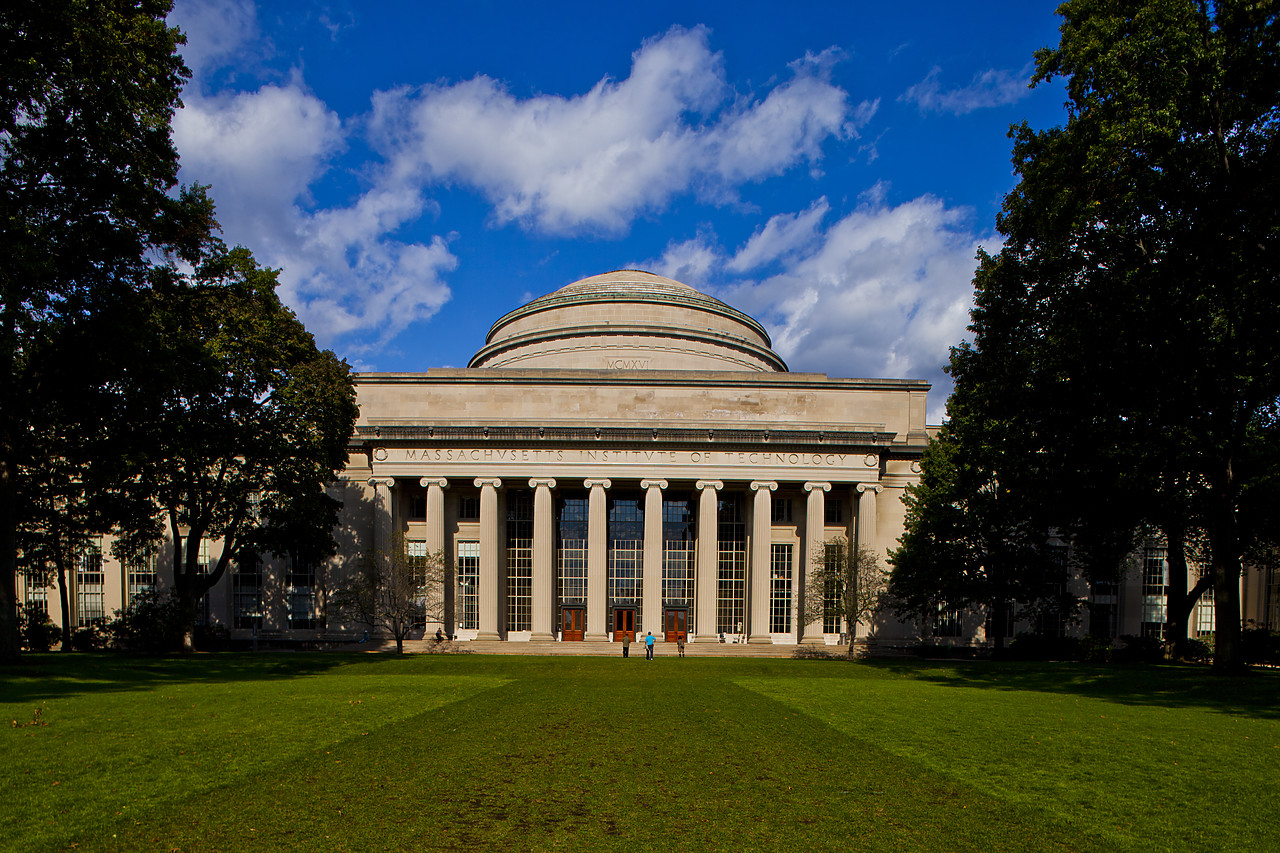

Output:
xmin=0 ymin=654 xmax=1280 ymax=853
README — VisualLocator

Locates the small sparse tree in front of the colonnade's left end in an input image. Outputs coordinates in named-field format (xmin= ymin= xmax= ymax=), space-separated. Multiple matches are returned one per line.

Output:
xmin=330 ymin=534 xmax=448 ymax=654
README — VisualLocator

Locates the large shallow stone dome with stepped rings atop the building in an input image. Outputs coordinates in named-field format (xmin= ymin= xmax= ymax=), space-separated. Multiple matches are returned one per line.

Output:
xmin=470 ymin=269 xmax=787 ymax=371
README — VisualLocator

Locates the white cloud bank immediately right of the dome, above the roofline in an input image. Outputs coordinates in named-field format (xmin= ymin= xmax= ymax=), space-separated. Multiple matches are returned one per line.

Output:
xmin=643 ymin=192 xmax=998 ymax=423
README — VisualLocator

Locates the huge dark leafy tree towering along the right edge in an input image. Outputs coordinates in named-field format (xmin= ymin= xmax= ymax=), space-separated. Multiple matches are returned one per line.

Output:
xmin=916 ymin=0 xmax=1280 ymax=669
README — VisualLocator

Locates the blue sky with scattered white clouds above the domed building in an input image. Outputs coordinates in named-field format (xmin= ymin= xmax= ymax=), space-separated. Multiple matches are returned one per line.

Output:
xmin=170 ymin=0 xmax=1065 ymax=423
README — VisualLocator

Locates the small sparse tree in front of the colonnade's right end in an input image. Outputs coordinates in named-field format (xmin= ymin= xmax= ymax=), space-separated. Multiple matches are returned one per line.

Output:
xmin=801 ymin=537 xmax=887 ymax=660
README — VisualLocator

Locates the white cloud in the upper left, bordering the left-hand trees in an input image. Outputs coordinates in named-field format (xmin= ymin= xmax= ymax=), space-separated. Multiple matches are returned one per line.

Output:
xmin=163 ymin=4 xmax=457 ymax=353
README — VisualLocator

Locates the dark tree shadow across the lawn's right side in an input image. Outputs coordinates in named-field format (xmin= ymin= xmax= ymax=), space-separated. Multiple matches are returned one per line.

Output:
xmin=863 ymin=661 xmax=1280 ymax=720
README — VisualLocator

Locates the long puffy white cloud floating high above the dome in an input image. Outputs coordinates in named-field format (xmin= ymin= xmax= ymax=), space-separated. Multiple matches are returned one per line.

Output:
xmin=371 ymin=27 xmax=874 ymax=233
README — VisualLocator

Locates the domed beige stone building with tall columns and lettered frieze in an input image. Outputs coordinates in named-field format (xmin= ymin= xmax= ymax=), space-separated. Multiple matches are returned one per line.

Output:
xmin=344 ymin=270 xmax=929 ymax=643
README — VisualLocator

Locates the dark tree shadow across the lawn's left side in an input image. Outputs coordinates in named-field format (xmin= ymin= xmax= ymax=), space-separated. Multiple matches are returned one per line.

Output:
xmin=0 ymin=652 xmax=419 ymax=702
